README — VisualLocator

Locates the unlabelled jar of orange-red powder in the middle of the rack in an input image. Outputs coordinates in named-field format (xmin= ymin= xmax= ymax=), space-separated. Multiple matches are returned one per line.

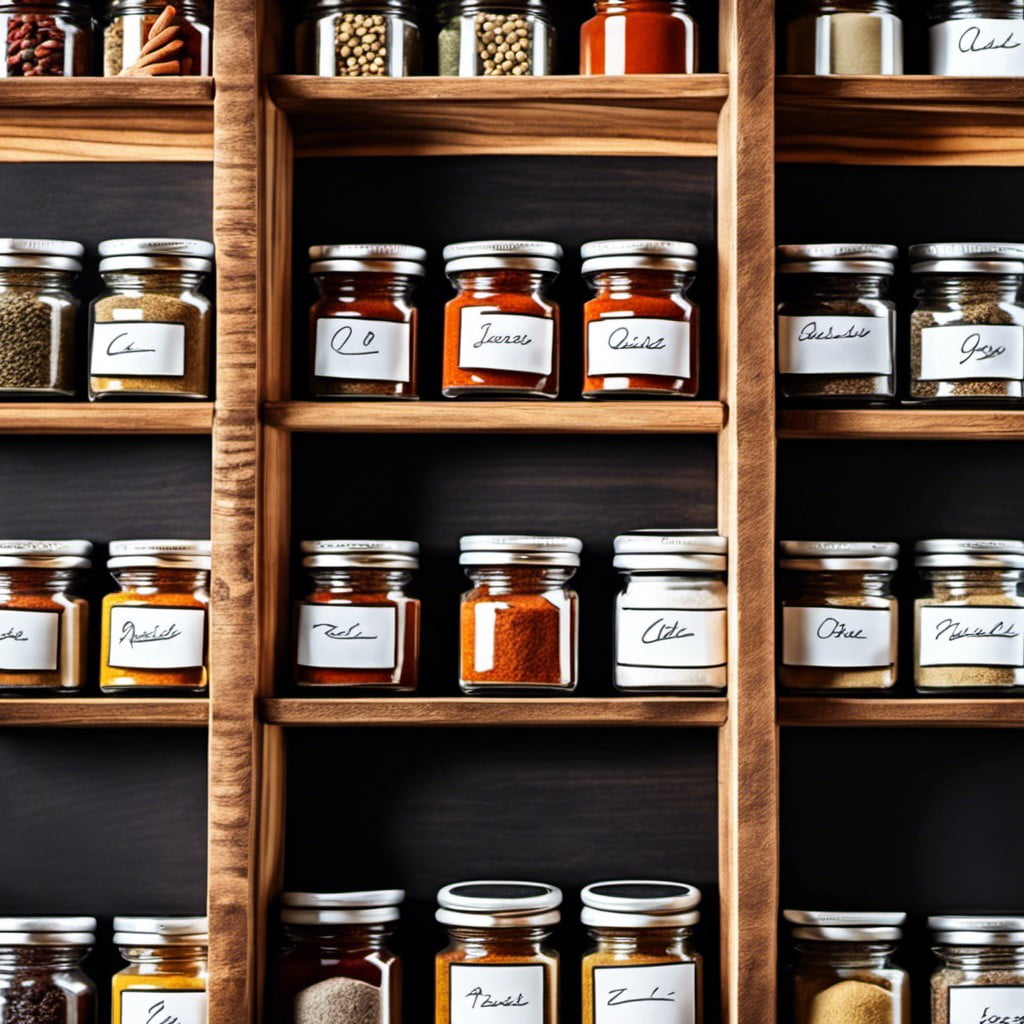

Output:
xmin=459 ymin=534 xmax=583 ymax=694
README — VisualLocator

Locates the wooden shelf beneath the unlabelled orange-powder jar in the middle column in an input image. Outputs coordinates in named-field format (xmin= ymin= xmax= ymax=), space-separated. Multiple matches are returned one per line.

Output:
xmin=262 ymin=696 xmax=728 ymax=726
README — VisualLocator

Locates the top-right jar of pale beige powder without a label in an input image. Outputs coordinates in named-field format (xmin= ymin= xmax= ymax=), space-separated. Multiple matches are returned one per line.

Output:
xmin=785 ymin=0 xmax=903 ymax=75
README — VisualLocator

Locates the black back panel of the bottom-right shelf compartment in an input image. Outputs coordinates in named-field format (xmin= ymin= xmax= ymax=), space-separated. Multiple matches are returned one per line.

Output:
xmin=781 ymin=729 xmax=1024 ymax=1024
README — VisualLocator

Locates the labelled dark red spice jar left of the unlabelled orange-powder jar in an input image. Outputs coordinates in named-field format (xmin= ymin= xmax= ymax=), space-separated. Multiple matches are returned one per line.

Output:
xmin=295 ymin=541 xmax=420 ymax=693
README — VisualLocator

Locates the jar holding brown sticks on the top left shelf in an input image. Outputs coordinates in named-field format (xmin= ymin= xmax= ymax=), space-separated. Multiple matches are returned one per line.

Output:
xmin=103 ymin=0 xmax=213 ymax=78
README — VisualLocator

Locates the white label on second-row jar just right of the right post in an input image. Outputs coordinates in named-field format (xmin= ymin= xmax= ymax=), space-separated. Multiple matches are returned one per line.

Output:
xmin=778 ymin=316 xmax=893 ymax=374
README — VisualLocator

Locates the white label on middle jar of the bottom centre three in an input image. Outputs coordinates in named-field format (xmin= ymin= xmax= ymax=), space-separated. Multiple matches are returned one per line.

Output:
xmin=449 ymin=964 xmax=547 ymax=1024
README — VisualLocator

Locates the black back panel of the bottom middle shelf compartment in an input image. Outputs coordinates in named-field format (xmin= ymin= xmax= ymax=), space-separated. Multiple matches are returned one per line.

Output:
xmin=285 ymin=729 xmax=719 ymax=1024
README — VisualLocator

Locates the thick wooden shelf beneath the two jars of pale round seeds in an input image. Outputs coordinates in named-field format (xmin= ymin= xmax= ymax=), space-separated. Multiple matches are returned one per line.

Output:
xmin=270 ymin=75 xmax=729 ymax=157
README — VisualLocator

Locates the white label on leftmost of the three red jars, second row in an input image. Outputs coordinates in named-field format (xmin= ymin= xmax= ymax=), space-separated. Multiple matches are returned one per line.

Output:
xmin=313 ymin=316 xmax=413 ymax=382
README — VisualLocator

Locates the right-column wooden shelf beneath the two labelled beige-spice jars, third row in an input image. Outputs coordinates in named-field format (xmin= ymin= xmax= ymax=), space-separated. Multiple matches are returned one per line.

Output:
xmin=778 ymin=697 xmax=1024 ymax=729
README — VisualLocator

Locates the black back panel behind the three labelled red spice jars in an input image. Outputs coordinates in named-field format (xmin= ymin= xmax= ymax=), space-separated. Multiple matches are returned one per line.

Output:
xmin=292 ymin=157 xmax=718 ymax=400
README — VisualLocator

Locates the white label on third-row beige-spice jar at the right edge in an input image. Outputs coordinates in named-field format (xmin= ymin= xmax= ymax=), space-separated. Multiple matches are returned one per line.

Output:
xmin=918 ymin=606 xmax=1024 ymax=669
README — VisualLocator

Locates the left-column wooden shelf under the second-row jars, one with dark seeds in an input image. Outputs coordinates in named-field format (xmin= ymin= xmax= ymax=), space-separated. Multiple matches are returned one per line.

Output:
xmin=0 ymin=401 xmax=213 ymax=434
